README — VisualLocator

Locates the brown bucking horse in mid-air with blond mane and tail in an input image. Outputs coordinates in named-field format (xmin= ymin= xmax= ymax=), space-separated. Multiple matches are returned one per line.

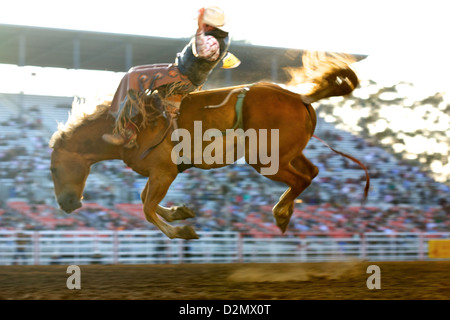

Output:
xmin=50 ymin=52 xmax=367 ymax=239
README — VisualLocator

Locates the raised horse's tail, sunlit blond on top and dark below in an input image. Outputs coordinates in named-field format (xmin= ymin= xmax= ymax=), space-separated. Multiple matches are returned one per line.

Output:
xmin=287 ymin=51 xmax=359 ymax=104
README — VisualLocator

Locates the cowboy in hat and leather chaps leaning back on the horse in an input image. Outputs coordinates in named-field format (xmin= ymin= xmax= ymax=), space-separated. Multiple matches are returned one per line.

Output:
xmin=102 ymin=6 xmax=240 ymax=148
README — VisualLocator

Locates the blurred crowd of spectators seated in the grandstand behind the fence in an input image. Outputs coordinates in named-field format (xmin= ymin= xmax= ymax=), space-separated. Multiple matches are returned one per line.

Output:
xmin=0 ymin=79 xmax=450 ymax=233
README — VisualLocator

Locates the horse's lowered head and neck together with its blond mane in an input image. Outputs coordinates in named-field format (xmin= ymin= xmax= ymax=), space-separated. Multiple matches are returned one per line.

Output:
xmin=49 ymin=100 xmax=118 ymax=213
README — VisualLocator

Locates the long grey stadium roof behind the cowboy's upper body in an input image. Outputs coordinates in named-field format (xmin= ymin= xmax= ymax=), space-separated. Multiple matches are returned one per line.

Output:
xmin=0 ymin=24 xmax=361 ymax=85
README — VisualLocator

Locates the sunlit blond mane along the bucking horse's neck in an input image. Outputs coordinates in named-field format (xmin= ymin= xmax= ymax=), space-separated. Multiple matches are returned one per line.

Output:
xmin=49 ymin=98 xmax=111 ymax=148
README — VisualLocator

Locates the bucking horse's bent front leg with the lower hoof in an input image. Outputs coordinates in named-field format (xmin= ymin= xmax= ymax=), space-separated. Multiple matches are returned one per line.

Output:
xmin=141 ymin=175 xmax=198 ymax=239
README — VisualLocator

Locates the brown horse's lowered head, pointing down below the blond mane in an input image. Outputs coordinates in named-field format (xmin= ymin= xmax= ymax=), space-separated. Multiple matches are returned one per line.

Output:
xmin=50 ymin=148 xmax=91 ymax=213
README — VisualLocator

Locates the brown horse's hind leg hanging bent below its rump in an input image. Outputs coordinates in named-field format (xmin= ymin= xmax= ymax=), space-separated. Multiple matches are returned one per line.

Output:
xmin=270 ymin=154 xmax=319 ymax=233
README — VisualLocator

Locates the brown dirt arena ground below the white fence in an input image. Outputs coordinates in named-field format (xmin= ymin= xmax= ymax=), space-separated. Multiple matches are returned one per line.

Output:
xmin=0 ymin=261 xmax=450 ymax=300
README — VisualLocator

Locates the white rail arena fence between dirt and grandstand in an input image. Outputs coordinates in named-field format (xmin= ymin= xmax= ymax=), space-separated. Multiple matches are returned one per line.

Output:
xmin=0 ymin=231 xmax=450 ymax=265
